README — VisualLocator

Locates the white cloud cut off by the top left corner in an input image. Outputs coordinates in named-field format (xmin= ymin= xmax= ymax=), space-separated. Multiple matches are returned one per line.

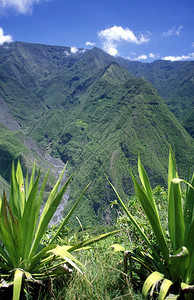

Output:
xmin=0 ymin=0 xmax=49 ymax=14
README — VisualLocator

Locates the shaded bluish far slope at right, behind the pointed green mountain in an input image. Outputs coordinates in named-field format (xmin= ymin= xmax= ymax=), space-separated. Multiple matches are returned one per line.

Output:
xmin=118 ymin=58 xmax=194 ymax=136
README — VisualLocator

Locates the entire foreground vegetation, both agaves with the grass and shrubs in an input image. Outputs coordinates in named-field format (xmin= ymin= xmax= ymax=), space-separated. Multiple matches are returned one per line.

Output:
xmin=0 ymin=150 xmax=194 ymax=300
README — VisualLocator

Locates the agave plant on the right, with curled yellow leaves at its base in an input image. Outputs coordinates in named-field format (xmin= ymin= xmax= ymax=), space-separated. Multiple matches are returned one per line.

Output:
xmin=107 ymin=149 xmax=194 ymax=300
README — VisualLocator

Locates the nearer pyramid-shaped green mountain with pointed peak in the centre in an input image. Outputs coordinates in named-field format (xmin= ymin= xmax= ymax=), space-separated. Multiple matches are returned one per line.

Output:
xmin=31 ymin=63 xmax=193 ymax=224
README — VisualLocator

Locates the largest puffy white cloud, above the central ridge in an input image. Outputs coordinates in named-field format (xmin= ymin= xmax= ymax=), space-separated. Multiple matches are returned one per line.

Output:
xmin=98 ymin=25 xmax=149 ymax=56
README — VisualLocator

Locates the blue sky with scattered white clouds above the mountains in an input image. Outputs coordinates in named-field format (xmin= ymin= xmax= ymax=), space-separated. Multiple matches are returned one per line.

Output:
xmin=0 ymin=0 xmax=194 ymax=62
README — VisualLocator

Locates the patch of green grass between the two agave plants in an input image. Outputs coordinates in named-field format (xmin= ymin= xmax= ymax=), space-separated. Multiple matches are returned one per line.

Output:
xmin=23 ymin=233 xmax=142 ymax=300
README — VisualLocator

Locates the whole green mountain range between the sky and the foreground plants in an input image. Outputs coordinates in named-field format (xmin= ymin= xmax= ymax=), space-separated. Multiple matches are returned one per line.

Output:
xmin=0 ymin=42 xmax=194 ymax=225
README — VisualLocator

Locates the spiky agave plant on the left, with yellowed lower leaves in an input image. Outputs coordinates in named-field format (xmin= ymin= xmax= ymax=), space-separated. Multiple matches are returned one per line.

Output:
xmin=0 ymin=161 xmax=120 ymax=300
